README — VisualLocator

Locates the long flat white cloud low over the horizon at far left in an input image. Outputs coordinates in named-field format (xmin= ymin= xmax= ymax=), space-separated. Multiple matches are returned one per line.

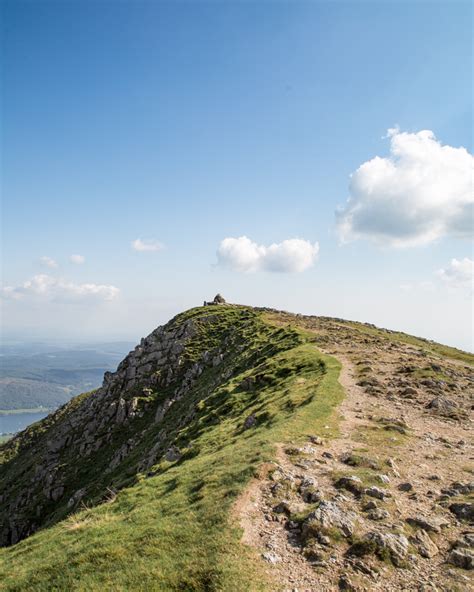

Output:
xmin=1 ymin=274 xmax=120 ymax=300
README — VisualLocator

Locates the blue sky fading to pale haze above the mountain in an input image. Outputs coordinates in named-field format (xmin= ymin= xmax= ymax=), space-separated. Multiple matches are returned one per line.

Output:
xmin=2 ymin=1 xmax=472 ymax=349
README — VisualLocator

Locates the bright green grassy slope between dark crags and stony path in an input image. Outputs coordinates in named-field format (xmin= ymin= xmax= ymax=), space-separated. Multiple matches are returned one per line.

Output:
xmin=0 ymin=307 xmax=342 ymax=591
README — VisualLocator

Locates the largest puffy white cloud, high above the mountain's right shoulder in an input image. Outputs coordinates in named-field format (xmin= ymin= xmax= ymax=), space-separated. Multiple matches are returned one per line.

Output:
xmin=336 ymin=129 xmax=474 ymax=247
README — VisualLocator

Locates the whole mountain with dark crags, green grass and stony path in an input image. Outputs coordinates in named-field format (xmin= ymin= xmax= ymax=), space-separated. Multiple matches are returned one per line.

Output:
xmin=0 ymin=308 xmax=474 ymax=591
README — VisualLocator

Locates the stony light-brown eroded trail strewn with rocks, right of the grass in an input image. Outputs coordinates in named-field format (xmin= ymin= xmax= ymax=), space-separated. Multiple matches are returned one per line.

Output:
xmin=236 ymin=332 xmax=474 ymax=592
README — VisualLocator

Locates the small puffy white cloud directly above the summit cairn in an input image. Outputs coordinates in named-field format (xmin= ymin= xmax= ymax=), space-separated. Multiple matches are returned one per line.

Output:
xmin=217 ymin=236 xmax=319 ymax=273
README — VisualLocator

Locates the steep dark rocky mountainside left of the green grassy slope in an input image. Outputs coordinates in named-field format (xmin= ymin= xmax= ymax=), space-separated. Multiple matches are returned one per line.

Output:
xmin=0 ymin=308 xmax=278 ymax=545
